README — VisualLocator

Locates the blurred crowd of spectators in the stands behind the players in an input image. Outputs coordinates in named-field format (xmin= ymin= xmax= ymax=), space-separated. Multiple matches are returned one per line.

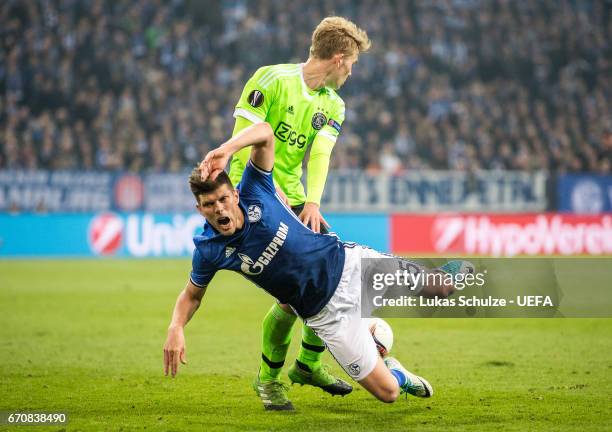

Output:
xmin=0 ymin=0 xmax=612 ymax=173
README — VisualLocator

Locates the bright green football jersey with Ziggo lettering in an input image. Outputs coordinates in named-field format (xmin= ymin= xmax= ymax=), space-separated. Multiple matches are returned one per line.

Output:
xmin=230 ymin=64 xmax=344 ymax=206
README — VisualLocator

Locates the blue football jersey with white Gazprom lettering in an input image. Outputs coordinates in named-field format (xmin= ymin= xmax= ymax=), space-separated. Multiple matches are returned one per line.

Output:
xmin=191 ymin=161 xmax=344 ymax=318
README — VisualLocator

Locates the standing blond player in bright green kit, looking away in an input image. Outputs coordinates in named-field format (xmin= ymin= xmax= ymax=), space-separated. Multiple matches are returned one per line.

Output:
xmin=225 ymin=17 xmax=370 ymax=410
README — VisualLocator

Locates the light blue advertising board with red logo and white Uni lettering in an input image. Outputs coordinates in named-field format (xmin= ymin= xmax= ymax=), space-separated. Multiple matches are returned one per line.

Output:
xmin=0 ymin=211 xmax=389 ymax=259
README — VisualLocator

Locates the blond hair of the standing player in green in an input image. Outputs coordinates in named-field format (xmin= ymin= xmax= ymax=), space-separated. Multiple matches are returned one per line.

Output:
xmin=310 ymin=17 xmax=371 ymax=60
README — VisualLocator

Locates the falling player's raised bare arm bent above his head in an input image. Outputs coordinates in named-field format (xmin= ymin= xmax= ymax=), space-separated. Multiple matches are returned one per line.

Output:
xmin=200 ymin=122 xmax=274 ymax=180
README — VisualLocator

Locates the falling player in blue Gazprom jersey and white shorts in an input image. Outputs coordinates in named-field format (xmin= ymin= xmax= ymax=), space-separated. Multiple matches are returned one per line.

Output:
xmin=164 ymin=122 xmax=468 ymax=410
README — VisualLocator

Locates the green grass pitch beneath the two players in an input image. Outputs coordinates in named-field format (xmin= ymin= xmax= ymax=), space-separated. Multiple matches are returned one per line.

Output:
xmin=0 ymin=260 xmax=612 ymax=432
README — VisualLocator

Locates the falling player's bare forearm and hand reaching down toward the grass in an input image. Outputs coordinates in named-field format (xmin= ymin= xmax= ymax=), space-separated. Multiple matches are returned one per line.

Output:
xmin=164 ymin=281 xmax=206 ymax=377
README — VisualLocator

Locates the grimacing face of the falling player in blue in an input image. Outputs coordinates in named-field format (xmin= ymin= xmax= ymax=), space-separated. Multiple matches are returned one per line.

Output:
xmin=196 ymin=184 xmax=244 ymax=236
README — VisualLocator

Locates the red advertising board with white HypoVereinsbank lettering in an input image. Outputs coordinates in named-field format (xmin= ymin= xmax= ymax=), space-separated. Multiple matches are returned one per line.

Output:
xmin=391 ymin=213 xmax=612 ymax=257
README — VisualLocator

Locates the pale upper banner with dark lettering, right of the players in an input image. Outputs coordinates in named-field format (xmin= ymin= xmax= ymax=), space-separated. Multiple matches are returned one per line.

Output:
xmin=321 ymin=171 xmax=546 ymax=212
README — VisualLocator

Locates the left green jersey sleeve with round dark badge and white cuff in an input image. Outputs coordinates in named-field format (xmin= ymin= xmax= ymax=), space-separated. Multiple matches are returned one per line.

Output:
xmin=234 ymin=67 xmax=277 ymax=123
